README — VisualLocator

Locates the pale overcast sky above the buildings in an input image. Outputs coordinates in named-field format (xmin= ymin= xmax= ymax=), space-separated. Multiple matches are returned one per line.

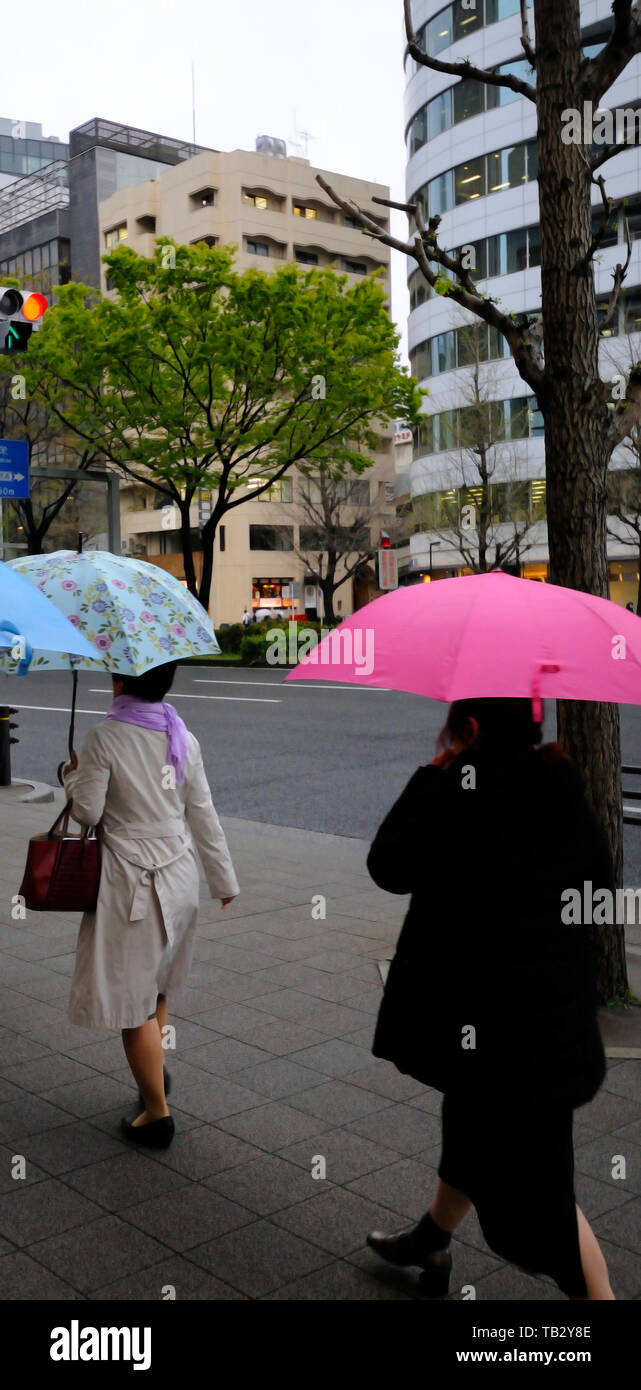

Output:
xmin=0 ymin=0 xmax=407 ymax=358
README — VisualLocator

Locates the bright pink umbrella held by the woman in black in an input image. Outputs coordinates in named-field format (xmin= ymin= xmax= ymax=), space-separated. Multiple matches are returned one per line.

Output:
xmin=286 ymin=571 xmax=641 ymax=719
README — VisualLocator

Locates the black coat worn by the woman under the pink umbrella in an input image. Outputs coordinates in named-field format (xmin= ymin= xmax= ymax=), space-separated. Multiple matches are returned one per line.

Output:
xmin=367 ymin=749 xmax=606 ymax=1106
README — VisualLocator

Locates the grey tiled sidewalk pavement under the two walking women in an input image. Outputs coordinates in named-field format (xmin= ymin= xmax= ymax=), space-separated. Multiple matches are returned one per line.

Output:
xmin=0 ymin=802 xmax=641 ymax=1301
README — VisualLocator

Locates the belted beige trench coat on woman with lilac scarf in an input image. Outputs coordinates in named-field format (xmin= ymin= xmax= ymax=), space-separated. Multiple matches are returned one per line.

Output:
xmin=64 ymin=720 xmax=239 ymax=1029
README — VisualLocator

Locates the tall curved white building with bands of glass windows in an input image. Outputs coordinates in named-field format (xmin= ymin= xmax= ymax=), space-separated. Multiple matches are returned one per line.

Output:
xmin=400 ymin=0 xmax=641 ymax=603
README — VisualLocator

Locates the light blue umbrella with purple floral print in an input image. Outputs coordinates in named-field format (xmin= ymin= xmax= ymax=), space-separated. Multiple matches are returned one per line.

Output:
xmin=0 ymin=550 xmax=220 ymax=676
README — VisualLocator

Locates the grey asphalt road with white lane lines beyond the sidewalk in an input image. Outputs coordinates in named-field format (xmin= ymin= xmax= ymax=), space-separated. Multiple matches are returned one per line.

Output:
xmin=0 ymin=666 xmax=641 ymax=883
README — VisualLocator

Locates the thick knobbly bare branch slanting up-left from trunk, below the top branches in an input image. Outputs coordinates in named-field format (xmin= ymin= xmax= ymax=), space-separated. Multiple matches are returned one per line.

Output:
xmin=316 ymin=174 xmax=546 ymax=402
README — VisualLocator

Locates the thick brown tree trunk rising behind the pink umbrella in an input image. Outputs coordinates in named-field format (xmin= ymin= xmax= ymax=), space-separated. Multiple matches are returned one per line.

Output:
xmin=535 ymin=0 xmax=627 ymax=999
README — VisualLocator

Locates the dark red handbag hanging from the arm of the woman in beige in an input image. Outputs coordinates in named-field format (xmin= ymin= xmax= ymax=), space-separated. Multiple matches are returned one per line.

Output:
xmin=19 ymin=801 xmax=102 ymax=912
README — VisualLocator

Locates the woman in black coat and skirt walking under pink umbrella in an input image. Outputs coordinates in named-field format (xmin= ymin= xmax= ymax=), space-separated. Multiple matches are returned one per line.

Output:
xmin=367 ymin=699 xmax=615 ymax=1300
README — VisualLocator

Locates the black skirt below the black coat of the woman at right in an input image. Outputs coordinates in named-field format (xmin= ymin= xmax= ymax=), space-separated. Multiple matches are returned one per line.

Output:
xmin=438 ymin=1093 xmax=587 ymax=1298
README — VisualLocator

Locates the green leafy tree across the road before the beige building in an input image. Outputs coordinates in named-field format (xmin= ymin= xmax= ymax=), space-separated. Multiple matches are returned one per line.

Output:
xmin=29 ymin=239 xmax=421 ymax=609
